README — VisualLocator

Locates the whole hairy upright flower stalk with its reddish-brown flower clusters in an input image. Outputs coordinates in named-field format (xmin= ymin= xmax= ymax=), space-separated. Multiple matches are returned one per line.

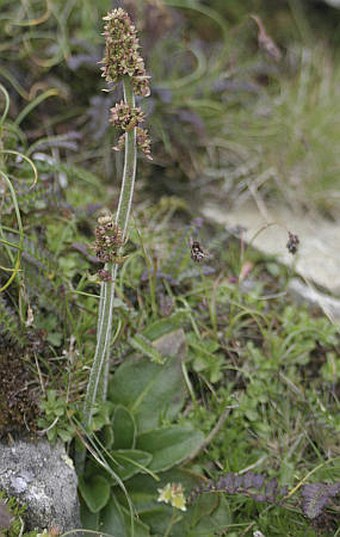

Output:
xmin=84 ymin=8 xmax=151 ymax=433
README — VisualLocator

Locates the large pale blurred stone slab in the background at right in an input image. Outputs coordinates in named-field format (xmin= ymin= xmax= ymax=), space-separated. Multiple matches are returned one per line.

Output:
xmin=202 ymin=204 xmax=340 ymax=296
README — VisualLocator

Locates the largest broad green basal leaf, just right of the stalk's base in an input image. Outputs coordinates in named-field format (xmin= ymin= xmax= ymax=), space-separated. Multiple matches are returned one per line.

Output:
xmin=108 ymin=348 xmax=186 ymax=432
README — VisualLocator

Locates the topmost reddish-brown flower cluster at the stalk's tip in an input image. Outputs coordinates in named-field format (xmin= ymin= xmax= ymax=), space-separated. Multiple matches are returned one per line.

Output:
xmin=102 ymin=8 xmax=150 ymax=97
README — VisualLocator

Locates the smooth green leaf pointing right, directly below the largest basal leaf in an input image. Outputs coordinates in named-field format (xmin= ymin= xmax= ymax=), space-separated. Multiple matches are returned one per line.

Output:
xmin=137 ymin=425 xmax=204 ymax=472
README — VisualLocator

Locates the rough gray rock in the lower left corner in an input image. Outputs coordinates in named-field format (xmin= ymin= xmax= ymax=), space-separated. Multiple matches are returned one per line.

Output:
xmin=0 ymin=440 xmax=81 ymax=535
